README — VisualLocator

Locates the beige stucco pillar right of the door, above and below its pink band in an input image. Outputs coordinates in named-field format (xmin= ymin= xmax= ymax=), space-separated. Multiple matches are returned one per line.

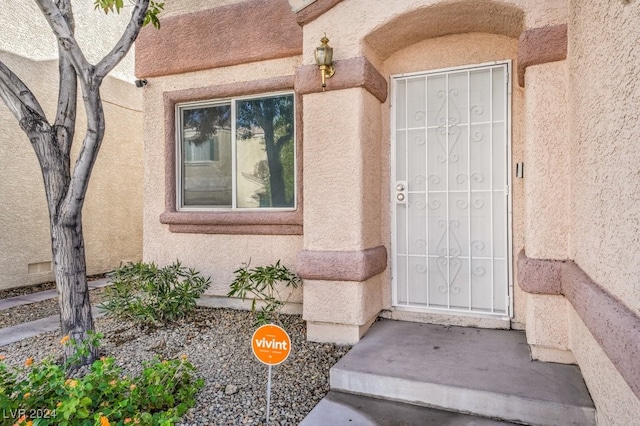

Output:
xmin=516 ymin=61 xmax=576 ymax=364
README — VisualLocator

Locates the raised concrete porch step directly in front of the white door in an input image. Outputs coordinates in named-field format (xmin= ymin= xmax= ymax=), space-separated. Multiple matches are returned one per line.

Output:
xmin=330 ymin=320 xmax=595 ymax=426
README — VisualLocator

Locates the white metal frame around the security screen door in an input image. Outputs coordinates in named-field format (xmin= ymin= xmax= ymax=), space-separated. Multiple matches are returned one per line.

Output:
xmin=389 ymin=60 xmax=514 ymax=319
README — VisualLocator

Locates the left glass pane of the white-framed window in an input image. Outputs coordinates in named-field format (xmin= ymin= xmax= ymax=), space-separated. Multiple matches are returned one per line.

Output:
xmin=181 ymin=104 xmax=232 ymax=207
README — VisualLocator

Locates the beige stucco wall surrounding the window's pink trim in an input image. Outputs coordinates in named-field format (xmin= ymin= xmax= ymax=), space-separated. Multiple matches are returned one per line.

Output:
xmin=143 ymin=57 xmax=302 ymax=302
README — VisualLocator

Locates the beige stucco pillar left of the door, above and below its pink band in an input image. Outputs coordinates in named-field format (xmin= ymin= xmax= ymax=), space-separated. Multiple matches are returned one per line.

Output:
xmin=303 ymin=88 xmax=388 ymax=344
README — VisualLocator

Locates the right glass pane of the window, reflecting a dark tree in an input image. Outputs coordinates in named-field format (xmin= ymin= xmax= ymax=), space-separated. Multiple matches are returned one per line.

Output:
xmin=236 ymin=95 xmax=295 ymax=208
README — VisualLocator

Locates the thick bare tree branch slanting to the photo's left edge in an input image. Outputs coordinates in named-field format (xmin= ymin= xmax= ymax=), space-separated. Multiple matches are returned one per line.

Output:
xmin=0 ymin=61 xmax=47 ymax=125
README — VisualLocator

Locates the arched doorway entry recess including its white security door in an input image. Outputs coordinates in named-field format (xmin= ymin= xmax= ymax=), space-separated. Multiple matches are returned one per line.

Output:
xmin=365 ymin=1 xmax=524 ymax=327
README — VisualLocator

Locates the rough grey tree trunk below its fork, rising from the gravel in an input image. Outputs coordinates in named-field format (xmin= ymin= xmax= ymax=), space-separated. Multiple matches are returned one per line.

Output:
xmin=51 ymin=213 xmax=98 ymax=364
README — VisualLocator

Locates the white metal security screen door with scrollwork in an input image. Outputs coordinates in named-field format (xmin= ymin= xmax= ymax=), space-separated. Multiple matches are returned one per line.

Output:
xmin=391 ymin=63 xmax=511 ymax=317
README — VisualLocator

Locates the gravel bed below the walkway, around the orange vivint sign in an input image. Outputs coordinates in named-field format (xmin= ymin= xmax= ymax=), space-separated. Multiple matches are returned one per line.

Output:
xmin=0 ymin=303 xmax=349 ymax=426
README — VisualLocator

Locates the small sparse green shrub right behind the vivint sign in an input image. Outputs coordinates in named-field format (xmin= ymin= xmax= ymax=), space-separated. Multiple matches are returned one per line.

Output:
xmin=227 ymin=260 xmax=301 ymax=325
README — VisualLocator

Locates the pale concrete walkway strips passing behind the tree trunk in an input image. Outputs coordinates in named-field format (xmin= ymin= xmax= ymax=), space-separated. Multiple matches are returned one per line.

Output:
xmin=0 ymin=278 xmax=109 ymax=346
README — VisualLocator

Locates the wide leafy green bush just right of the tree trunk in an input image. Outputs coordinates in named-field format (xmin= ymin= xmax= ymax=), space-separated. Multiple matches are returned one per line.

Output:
xmin=99 ymin=261 xmax=211 ymax=325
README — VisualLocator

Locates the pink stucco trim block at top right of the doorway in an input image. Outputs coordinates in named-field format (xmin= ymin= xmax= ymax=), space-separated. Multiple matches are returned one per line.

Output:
xmin=518 ymin=24 xmax=567 ymax=87
